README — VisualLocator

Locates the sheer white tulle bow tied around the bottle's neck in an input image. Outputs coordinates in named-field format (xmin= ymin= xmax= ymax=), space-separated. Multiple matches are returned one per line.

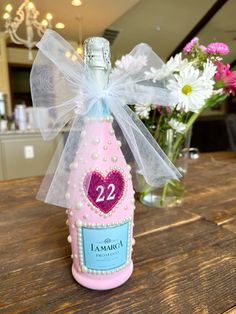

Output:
xmin=30 ymin=30 xmax=180 ymax=207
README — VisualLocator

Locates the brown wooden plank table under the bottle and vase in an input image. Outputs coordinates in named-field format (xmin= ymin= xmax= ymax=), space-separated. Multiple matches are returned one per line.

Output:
xmin=0 ymin=153 xmax=236 ymax=314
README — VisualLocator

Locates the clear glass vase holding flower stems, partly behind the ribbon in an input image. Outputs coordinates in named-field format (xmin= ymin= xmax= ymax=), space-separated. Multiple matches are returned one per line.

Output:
xmin=137 ymin=129 xmax=192 ymax=207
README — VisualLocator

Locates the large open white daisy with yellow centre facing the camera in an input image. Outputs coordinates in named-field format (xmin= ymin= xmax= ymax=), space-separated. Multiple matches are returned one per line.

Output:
xmin=167 ymin=66 xmax=213 ymax=112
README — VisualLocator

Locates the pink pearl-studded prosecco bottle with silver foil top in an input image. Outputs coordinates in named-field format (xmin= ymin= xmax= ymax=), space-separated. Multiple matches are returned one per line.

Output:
xmin=66 ymin=37 xmax=135 ymax=290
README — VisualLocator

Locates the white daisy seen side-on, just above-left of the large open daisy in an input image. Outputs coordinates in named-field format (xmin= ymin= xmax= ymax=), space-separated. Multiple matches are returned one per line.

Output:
xmin=145 ymin=53 xmax=190 ymax=83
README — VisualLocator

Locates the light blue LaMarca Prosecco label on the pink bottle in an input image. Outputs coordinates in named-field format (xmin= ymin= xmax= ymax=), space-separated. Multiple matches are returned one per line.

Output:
xmin=77 ymin=218 xmax=131 ymax=273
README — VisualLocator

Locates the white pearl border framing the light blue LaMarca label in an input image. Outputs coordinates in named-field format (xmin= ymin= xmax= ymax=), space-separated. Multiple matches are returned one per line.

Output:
xmin=75 ymin=216 xmax=132 ymax=275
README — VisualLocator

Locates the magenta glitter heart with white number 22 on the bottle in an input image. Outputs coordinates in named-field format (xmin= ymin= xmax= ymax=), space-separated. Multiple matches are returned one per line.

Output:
xmin=84 ymin=170 xmax=125 ymax=214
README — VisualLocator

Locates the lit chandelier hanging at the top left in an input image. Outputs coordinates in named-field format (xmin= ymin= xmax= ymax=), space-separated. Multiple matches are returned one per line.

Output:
xmin=3 ymin=0 xmax=65 ymax=60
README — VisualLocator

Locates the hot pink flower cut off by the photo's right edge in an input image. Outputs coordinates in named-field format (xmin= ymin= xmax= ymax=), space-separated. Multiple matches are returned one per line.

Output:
xmin=215 ymin=62 xmax=236 ymax=95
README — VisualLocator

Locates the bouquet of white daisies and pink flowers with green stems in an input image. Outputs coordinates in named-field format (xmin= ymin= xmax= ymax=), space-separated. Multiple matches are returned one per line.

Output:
xmin=134 ymin=37 xmax=236 ymax=207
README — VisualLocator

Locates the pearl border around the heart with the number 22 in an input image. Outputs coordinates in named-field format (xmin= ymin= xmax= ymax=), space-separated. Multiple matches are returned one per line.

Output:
xmin=80 ymin=166 xmax=129 ymax=218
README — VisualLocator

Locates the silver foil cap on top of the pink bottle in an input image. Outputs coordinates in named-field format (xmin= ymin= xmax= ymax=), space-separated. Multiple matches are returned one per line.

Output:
xmin=84 ymin=37 xmax=111 ymax=71
